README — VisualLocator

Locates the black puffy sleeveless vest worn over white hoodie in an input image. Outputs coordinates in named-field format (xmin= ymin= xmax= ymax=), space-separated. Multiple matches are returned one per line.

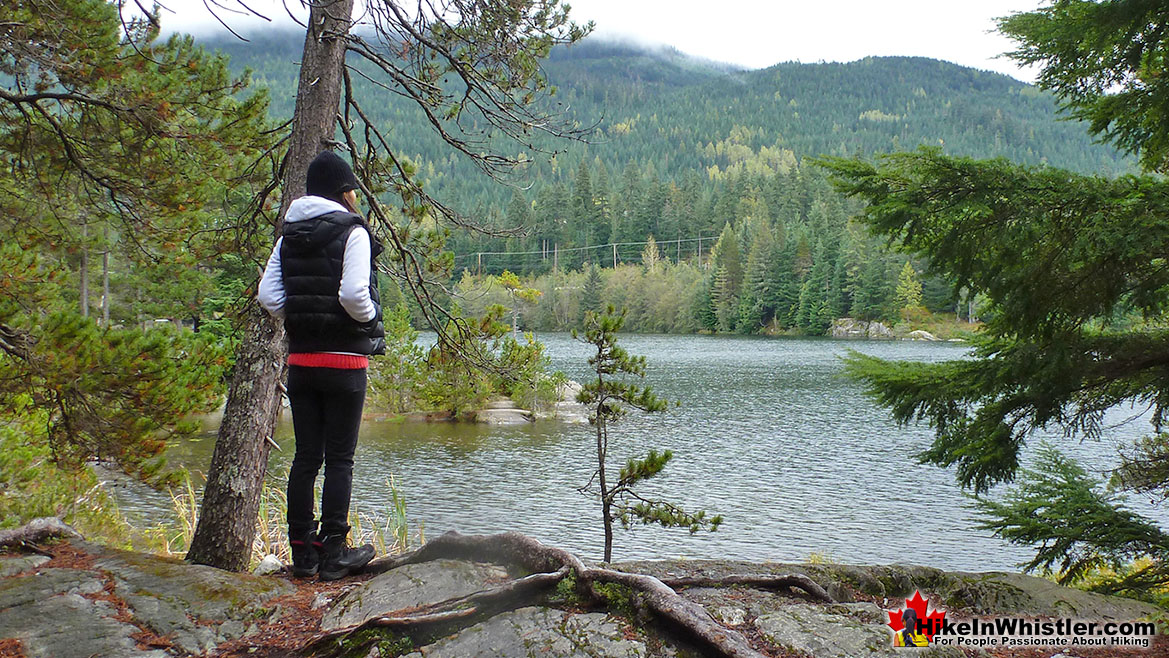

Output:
xmin=281 ymin=212 xmax=386 ymax=354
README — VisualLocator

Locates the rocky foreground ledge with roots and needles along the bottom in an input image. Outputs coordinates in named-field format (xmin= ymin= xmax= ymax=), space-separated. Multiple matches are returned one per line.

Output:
xmin=0 ymin=535 xmax=1169 ymax=658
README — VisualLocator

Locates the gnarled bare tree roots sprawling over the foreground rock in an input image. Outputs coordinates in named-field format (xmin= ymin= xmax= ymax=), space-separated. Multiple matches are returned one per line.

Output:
xmin=304 ymin=532 xmax=832 ymax=658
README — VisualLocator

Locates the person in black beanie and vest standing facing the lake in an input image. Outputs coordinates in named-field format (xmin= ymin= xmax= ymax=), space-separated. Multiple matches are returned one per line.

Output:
xmin=257 ymin=151 xmax=386 ymax=581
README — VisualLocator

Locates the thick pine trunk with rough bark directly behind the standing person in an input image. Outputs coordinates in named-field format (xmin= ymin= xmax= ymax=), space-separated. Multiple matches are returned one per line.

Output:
xmin=187 ymin=0 xmax=353 ymax=572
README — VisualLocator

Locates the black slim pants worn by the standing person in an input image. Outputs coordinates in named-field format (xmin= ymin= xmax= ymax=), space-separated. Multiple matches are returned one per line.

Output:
xmin=288 ymin=366 xmax=366 ymax=538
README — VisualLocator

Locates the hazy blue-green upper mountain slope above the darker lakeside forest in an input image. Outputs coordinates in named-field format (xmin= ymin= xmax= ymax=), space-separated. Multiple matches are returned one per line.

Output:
xmin=209 ymin=33 xmax=1133 ymax=206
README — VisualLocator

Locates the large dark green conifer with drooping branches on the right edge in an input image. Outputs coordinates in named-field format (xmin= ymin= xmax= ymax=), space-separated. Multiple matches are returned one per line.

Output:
xmin=825 ymin=0 xmax=1169 ymax=591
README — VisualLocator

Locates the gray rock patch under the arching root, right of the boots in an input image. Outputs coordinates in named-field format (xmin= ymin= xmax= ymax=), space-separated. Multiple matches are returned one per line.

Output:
xmin=320 ymin=560 xmax=507 ymax=630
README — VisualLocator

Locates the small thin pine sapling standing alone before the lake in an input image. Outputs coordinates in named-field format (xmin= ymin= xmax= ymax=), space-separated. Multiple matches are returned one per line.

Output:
xmin=573 ymin=305 xmax=722 ymax=562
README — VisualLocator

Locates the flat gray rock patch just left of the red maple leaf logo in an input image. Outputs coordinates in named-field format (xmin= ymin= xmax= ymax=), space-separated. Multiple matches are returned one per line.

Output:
xmin=755 ymin=603 xmax=962 ymax=658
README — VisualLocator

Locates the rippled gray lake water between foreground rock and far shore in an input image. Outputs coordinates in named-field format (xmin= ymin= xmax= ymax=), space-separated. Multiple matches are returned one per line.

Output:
xmin=129 ymin=334 xmax=1169 ymax=570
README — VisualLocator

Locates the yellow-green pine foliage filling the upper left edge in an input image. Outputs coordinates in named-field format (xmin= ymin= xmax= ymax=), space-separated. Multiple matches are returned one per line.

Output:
xmin=0 ymin=0 xmax=275 ymax=479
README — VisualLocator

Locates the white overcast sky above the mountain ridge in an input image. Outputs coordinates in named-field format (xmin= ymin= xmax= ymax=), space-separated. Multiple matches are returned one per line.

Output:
xmin=162 ymin=0 xmax=1045 ymax=82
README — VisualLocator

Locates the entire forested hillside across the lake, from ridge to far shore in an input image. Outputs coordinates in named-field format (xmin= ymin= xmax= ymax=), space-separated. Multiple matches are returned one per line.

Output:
xmin=213 ymin=34 xmax=1134 ymax=333
